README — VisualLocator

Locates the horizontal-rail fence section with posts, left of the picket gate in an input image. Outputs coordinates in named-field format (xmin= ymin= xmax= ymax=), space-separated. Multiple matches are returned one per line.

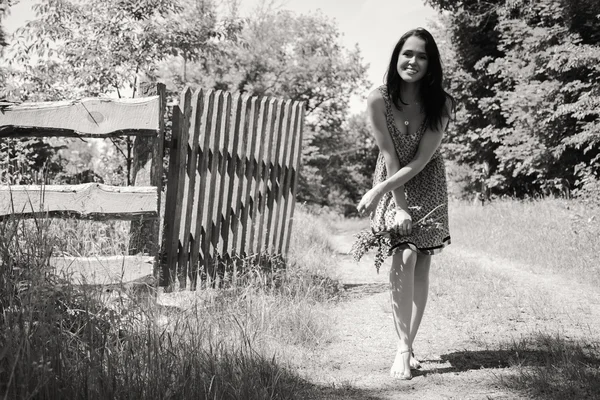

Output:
xmin=0 ymin=84 xmax=166 ymax=284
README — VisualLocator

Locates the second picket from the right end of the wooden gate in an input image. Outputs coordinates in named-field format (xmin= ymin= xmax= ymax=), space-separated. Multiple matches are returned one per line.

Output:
xmin=267 ymin=100 xmax=294 ymax=253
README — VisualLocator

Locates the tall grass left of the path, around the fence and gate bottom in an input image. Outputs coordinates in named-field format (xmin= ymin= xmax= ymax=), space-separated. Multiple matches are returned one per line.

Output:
xmin=0 ymin=209 xmax=338 ymax=399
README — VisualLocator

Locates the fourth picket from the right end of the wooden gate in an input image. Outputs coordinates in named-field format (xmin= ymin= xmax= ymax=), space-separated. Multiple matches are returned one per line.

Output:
xmin=247 ymin=98 xmax=274 ymax=255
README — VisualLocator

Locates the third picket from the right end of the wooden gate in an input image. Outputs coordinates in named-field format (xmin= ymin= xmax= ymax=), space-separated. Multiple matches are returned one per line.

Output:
xmin=256 ymin=99 xmax=283 ymax=254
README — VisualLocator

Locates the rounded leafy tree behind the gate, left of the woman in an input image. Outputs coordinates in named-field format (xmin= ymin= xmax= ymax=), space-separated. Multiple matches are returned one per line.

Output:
xmin=159 ymin=9 xmax=368 ymax=209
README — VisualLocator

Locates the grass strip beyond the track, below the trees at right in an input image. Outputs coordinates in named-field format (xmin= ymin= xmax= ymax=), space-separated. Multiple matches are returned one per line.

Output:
xmin=450 ymin=199 xmax=600 ymax=286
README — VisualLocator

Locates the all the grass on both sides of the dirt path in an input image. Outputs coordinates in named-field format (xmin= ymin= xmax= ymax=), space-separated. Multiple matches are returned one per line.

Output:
xmin=0 ymin=199 xmax=600 ymax=399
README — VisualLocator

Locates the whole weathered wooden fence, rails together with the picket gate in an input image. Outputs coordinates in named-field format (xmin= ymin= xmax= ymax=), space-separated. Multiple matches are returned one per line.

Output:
xmin=0 ymin=84 xmax=304 ymax=289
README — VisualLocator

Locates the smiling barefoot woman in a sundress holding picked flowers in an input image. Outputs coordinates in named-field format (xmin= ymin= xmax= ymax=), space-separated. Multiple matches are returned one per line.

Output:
xmin=358 ymin=28 xmax=454 ymax=379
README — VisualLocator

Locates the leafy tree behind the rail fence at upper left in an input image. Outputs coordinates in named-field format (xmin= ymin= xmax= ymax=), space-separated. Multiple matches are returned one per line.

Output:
xmin=5 ymin=0 xmax=237 ymax=183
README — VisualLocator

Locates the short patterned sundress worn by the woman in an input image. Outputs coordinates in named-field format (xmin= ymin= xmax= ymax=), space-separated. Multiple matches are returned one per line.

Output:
xmin=360 ymin=86 xmax=450 ymax=262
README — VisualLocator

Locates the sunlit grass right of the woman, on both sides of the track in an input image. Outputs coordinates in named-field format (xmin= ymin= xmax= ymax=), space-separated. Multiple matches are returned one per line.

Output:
xmin=431 ymin=199 xmax=600 ymax=400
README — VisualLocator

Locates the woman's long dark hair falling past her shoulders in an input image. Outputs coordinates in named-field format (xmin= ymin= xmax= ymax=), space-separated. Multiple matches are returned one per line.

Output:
xmin=385 ymin=28 xmax=455 ymax=130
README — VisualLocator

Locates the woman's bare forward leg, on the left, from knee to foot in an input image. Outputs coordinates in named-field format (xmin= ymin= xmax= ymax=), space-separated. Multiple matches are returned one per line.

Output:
xmin=390 ymin=248 xmax=417 ymax=379
